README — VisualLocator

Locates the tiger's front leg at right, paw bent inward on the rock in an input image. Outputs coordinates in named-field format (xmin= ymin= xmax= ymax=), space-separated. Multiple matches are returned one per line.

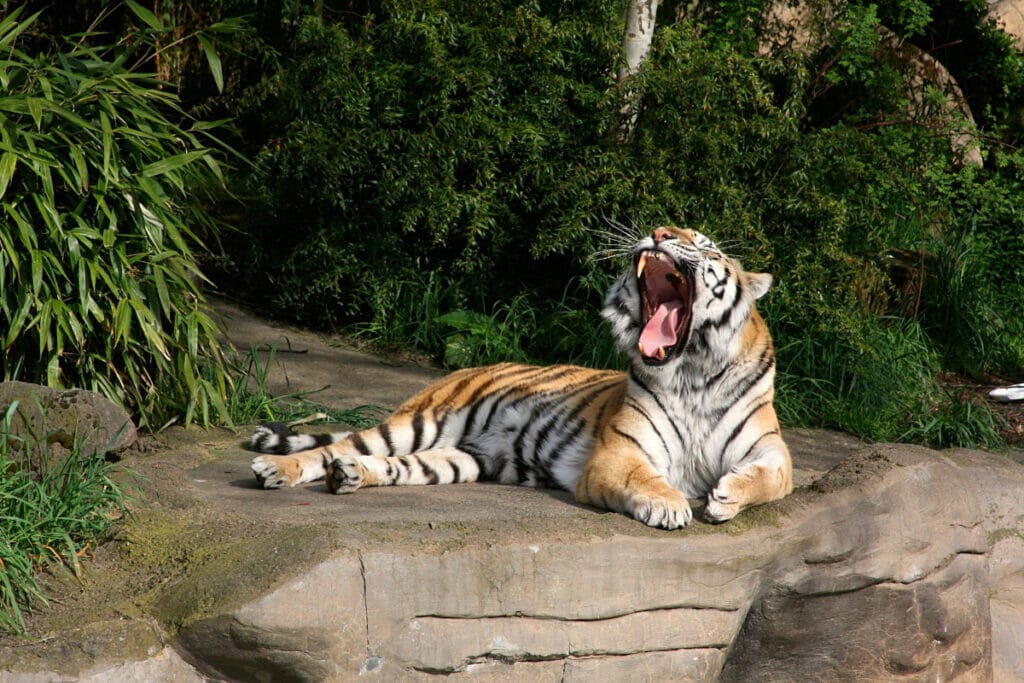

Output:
xmin=703 ymin=433 xmax=793 ymax=522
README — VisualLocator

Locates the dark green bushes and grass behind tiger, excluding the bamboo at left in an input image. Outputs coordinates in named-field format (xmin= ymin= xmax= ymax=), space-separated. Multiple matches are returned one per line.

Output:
xmin=211 ymin=0 xmax=1024 ymax=444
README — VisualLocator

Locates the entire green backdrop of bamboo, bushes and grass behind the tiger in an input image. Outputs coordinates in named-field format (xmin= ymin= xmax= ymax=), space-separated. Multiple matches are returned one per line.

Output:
xmin=0 ymin=0 xmax=1024 ymax=444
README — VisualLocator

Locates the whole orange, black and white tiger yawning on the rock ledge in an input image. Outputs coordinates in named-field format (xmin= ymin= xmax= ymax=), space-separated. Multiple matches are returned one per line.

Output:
xmin=249 ymin=226 xmax=793 ymax=529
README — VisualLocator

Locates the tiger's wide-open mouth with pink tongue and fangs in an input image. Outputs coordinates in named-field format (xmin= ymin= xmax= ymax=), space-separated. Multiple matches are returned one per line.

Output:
xmin=637 ymin=250 xmax=693 ymax=366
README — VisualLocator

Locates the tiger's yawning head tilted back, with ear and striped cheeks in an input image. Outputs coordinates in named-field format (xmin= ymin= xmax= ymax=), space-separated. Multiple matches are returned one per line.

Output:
xmin=602 ymin=227 xmax=772 ymax=366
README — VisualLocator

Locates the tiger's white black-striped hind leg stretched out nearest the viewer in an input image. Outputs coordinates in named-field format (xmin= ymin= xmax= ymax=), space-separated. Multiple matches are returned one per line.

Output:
xmin=326 ymin=446 xmax=480 ymax=494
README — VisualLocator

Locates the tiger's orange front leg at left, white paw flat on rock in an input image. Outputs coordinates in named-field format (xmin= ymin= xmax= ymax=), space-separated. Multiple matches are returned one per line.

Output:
xmin=575 ymin=432 xmax=693 ymax=529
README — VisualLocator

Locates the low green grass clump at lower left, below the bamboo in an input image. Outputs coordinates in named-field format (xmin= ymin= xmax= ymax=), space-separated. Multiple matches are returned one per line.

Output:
xmin=0 ymin=402 xmax=126 ymax=632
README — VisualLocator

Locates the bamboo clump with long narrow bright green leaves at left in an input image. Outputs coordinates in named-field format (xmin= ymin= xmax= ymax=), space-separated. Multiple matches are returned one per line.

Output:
xmin=0 ymin=10 xmax=232 ymax=428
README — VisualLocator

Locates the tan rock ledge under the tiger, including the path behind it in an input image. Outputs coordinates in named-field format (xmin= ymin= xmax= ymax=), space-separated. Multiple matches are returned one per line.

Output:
xmin=0 ymin=304 xmax=1024 ymax=681
